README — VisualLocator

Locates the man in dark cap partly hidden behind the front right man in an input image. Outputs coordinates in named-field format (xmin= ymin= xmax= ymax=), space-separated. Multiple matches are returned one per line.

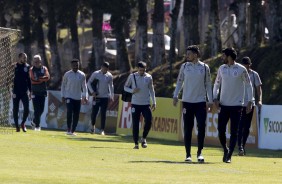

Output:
xmin=238 ymin=57 xmax=262 ymax=156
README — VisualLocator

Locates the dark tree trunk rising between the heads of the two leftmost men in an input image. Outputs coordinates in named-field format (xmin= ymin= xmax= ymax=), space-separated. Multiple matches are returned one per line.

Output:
xmin=22 ymin=0 xmax=31 ymax=63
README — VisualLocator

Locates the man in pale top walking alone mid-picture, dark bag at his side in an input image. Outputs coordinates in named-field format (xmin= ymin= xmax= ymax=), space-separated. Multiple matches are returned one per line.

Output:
xmin=124 ymin=61 xmax=156 ymax=149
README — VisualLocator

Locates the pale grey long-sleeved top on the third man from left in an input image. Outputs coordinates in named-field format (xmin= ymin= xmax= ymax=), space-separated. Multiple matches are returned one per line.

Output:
xmin=61 ymin=70 xmax=87 ymax=100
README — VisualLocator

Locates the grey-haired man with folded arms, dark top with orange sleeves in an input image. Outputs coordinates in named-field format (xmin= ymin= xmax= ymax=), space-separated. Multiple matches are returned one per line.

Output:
xmin=29 ymin=55 xmax=50 ymax=131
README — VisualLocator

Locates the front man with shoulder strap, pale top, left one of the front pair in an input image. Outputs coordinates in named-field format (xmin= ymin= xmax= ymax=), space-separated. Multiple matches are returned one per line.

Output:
xmin=173 ymin=45 xmax=213 ymax=162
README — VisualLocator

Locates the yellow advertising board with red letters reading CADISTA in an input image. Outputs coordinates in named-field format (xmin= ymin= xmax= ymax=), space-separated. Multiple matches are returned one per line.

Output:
xmin=117 ymin=98 xmax=181 ymax=140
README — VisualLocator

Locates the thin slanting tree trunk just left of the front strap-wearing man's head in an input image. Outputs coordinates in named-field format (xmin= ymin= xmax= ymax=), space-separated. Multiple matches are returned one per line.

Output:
xmin=168 ymin=0 xmax=181 ymax=83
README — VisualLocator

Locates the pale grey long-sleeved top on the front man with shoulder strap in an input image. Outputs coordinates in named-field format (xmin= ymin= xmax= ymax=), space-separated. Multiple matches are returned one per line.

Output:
xmin=173 ymin=61 xmax=213 ymax=103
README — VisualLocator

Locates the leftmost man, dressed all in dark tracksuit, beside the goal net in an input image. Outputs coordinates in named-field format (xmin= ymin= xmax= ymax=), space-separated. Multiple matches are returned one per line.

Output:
xmin=13 ymin=53 xmax=31 ymax=132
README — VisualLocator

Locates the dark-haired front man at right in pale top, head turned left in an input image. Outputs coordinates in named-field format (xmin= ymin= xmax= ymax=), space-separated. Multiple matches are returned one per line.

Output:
xmin=213 ymin=48 xmax=253 ymax=163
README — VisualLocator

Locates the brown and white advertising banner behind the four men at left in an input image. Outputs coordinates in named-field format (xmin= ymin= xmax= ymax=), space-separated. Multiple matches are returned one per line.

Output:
xmin=10 ymin=91 xmax=119 ymax=133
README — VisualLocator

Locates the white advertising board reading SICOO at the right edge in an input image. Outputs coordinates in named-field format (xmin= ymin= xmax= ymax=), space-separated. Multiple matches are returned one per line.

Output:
xmin=258 ymin=105 xmax=282 ymax=150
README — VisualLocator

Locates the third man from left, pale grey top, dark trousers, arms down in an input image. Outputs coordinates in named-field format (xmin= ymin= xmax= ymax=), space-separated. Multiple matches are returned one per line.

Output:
xmin=61 ymin=59 xmax=87 ymax=136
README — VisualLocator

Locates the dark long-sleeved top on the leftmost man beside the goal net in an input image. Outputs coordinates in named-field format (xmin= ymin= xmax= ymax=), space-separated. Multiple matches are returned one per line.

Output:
xmin=13 ymin=63 xmax=31 ymax=95
